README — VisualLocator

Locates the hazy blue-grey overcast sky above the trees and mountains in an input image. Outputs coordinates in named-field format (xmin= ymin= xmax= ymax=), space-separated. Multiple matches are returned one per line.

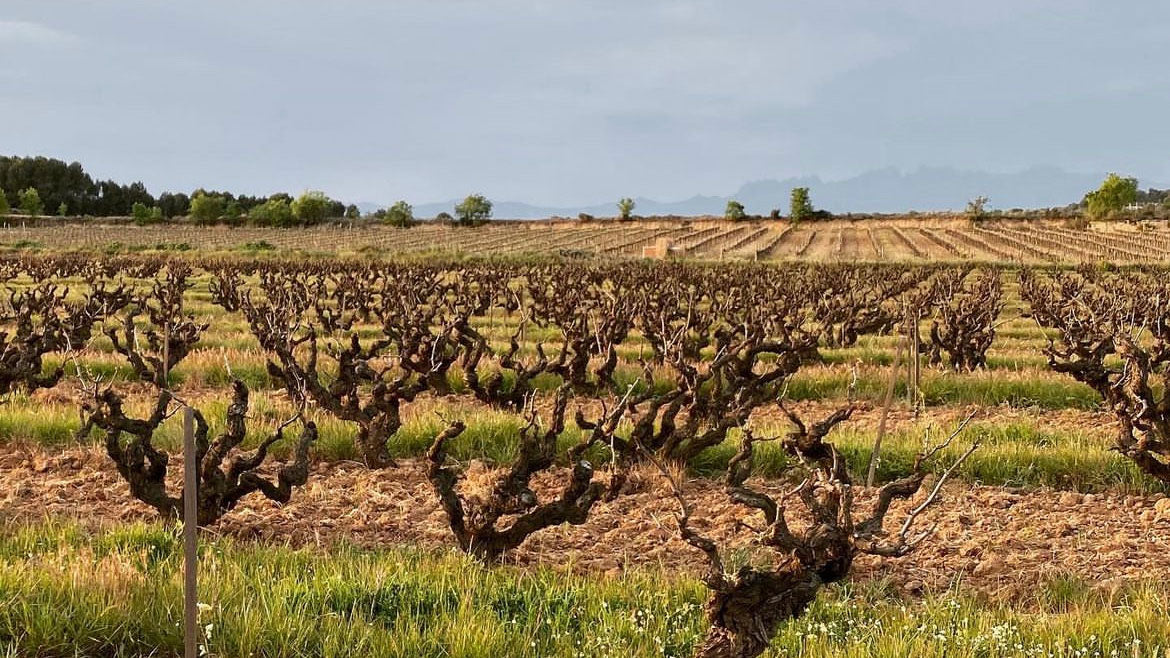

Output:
xmin=0 ymin=0 xmax=1170 ymax=205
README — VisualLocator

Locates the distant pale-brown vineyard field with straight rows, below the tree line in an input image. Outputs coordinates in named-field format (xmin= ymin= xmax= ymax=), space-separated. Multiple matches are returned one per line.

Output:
xmin=0 ymin=219 xmax=1170 ymax=263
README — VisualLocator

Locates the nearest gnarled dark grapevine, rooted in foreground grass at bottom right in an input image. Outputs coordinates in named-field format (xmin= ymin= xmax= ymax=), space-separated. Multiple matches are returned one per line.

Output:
xmin=652 ymin=410 xmax=975 ymax=658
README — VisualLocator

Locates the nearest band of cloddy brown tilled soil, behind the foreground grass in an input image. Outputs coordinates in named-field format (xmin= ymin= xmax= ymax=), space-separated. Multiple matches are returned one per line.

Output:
xmin=0 ymin=446 xmax=1170 ymax=597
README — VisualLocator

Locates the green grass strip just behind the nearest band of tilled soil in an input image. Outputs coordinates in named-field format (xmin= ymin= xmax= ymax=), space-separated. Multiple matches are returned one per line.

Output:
xmin=0 ymin=386 xmax=1151 ymax=493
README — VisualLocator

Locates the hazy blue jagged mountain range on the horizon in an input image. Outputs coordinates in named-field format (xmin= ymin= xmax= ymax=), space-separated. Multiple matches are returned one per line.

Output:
xmin=386 ymin=166 xmax=1149 ymax=219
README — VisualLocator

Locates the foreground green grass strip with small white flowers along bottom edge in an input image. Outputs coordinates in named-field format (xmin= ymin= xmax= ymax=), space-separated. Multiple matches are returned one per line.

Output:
xmin=0 ymin=525 xmax=1170 ymax=658
